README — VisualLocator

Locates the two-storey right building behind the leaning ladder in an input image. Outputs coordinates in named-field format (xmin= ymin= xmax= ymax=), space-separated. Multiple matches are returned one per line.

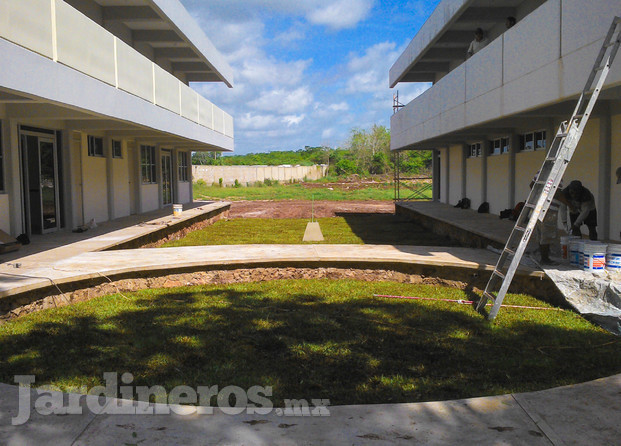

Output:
xmin=390 ymin=0 xmax=621 ymax=240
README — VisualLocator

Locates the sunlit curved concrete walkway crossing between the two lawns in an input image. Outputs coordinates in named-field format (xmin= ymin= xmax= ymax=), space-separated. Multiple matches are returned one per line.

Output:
xmin=0 ymin=245 xmax=543 ymax=298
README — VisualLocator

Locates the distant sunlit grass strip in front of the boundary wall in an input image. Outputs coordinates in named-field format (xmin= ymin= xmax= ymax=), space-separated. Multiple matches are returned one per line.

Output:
xmin=194 ymin=183 xmax=394 ymax=201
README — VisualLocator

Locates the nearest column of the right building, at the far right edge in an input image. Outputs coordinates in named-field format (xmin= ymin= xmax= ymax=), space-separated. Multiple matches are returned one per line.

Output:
xmin=597 ymin=109 xmax=613 ymax=240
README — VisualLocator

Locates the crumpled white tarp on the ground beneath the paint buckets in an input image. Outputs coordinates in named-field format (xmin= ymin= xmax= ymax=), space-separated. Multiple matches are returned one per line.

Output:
xmin=542 ymin=264 xmax=621 ymax=335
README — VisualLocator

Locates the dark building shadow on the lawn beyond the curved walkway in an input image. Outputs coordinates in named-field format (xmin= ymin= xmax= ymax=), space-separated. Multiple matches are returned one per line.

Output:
xmin=336 ymin=212 xmax=459 ymax=246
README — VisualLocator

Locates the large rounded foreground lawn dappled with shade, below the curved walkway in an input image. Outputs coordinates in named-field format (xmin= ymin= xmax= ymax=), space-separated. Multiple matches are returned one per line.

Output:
xmin=0 ymin=280 xmax=621 ymax=406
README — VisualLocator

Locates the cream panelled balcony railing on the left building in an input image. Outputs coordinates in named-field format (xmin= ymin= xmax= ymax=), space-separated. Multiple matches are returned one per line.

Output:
xmin=0 ymin=0 xmax=233 ymax=138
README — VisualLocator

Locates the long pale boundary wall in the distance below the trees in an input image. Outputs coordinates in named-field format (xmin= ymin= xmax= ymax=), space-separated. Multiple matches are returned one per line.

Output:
xmin=192 ymin=164 xmax=328 ymax=186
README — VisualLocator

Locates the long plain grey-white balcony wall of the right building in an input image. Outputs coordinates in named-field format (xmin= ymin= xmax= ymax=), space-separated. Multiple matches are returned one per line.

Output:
xmin=391 ymin=0 xmax=621 ymax=150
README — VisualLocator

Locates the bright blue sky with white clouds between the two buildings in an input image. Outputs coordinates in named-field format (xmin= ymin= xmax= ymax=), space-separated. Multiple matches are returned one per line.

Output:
xmin=181 ymin=0 xmax=439 ymax=154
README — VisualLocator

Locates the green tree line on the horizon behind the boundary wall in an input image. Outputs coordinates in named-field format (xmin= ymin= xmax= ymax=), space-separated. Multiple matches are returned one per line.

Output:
xmin=192 ymin=125 xmax=432 ymax=176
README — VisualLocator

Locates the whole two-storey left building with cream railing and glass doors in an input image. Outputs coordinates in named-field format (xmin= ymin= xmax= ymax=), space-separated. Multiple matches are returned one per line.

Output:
xmin=0 ymin=0 xmax=233 ymax=236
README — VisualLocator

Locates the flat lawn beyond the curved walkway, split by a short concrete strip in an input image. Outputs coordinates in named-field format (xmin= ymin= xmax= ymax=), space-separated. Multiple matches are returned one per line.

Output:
xmin=163 ymin=214 xmax=454 ymax=247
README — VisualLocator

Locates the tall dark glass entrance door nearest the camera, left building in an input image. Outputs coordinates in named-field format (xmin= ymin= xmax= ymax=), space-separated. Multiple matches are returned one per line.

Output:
xmin=20 ymin=131 xmax=60 ymax=235
